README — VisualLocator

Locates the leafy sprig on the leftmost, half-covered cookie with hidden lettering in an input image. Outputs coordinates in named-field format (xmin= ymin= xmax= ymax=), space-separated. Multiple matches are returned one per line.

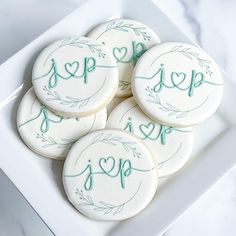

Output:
xmin=36 ymin=133 xmax=77 ymax=149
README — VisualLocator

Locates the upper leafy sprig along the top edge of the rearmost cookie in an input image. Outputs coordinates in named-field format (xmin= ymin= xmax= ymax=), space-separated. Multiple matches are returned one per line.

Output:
xmin=96 ymin=21 xmax=151 ymax=41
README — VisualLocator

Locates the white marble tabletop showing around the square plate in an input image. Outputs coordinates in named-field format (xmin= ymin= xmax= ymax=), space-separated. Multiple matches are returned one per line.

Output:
xmin=0 ymin=0 xmax=236 ymax=236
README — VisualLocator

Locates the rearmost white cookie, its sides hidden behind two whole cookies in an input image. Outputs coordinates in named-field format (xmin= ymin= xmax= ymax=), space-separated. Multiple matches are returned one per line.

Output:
xmin=88 ymin=19 xmax=160 ymax=97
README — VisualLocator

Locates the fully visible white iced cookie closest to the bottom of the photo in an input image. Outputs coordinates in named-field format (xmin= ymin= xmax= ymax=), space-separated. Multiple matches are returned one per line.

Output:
xmin=63 ymin=129 xmax=158 ymax=220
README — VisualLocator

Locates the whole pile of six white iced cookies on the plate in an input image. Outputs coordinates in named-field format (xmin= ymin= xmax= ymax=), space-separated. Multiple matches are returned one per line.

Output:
xmin=17 ymin=19 xmax=223 ymax=220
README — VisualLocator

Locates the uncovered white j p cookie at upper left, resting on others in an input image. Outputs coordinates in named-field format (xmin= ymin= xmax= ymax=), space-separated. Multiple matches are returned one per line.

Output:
xmin=32 ymin=37 xmax=118 ymax=116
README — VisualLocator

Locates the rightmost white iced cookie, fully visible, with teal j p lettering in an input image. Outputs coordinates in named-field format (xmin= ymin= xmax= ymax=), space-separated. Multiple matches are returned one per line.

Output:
xmin=132 ymin=42 xmax=223 ymax=127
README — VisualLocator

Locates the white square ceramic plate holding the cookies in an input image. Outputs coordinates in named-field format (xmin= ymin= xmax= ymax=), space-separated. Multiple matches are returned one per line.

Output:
xmin=0 ymin=0 xmax=236 ymax=236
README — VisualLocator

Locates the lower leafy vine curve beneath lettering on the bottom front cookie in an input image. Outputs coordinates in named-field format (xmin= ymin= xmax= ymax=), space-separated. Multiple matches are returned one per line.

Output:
xmin=75 ymin=182 xmax=141 ymax=215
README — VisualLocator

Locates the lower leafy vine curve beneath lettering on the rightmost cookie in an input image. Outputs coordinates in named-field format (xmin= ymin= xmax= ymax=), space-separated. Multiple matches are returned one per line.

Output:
xmin=145 ymin=86 xmax=208 ymax=119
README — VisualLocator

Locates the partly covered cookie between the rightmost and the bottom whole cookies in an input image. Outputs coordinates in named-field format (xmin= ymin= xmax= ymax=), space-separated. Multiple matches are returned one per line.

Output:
xmin=106 ymin=97 xmax=193 ymax=177
